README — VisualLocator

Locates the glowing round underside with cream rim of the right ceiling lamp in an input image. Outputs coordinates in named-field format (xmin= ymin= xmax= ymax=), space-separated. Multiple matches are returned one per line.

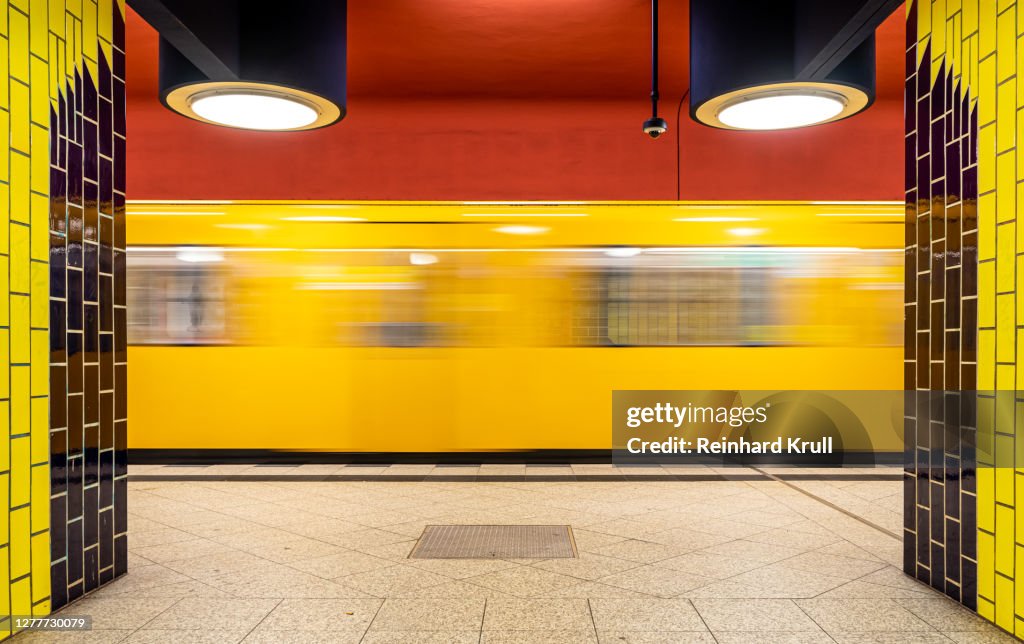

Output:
xmin=695 ymin=83 xmax=870 ymax=130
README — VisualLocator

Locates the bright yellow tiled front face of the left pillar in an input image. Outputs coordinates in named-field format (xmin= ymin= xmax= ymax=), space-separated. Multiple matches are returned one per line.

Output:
xmin=0 ymin=0 xmax=57 ymax=637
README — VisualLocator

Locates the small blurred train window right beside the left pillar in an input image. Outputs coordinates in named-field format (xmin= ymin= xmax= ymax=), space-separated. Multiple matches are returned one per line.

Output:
xmin=127 ymin=248 xmax=227 ymax=345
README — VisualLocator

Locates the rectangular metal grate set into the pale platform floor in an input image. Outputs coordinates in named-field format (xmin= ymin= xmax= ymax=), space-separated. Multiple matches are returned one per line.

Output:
xmin=409 ymin=525 xmax=577 ymax=559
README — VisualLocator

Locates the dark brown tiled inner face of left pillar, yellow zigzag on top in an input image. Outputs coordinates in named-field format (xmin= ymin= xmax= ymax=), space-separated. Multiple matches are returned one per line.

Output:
xmin=44 ymin=0 xmax=128 ymax=608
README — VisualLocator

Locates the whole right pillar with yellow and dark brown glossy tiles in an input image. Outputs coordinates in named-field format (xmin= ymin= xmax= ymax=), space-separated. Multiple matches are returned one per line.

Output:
xmin=904 ymin=0 xmax=1024 ymax=636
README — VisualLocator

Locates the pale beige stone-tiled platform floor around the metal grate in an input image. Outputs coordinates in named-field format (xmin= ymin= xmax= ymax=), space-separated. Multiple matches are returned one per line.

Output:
xmin=28 ymin=466 xmax=1014 ymax=644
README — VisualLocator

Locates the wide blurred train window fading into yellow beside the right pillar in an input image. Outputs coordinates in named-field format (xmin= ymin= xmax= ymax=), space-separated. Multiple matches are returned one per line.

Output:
xmin=572 ymin=248 xmax=899 ymax=346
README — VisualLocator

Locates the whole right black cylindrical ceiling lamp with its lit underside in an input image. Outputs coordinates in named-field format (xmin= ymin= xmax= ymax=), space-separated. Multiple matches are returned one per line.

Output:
xmin=690 ymin=0 xmax=872 ymax=130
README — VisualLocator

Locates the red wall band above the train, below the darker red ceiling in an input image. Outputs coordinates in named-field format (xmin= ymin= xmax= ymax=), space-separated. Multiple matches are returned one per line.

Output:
xmin=128 ymin=0 xmax=903 ymax=201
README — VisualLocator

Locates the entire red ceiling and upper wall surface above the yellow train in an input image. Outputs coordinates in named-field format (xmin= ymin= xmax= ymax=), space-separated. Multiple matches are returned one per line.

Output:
xmin=127 ymin=0 xmax=904 ymax=200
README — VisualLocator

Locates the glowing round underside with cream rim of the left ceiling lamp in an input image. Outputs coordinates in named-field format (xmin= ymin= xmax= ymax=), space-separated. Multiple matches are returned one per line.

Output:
xmin=164 ymin=82 xmax=342 ymax=132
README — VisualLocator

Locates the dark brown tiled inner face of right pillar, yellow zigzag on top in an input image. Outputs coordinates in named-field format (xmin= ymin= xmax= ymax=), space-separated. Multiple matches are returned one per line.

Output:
xmin=903 ymin=0 xmax=978 ymax=608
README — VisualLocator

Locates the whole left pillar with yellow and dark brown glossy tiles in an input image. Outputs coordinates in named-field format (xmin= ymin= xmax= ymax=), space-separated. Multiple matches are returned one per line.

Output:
xmin=0 ymin=0 xmax=126 ymax=638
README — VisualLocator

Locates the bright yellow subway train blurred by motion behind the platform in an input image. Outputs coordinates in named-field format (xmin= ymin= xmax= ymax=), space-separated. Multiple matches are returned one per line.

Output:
xmin=127 ymin=202 xmax=903 ymax=453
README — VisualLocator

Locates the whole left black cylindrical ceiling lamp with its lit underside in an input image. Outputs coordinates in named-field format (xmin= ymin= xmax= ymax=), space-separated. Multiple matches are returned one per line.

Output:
xmin=143 ymin=0 xmax=346 ymax=131
